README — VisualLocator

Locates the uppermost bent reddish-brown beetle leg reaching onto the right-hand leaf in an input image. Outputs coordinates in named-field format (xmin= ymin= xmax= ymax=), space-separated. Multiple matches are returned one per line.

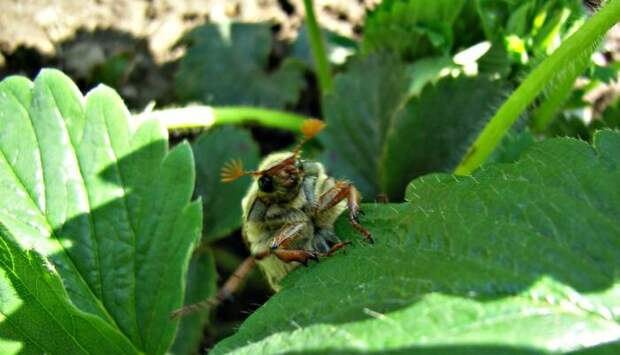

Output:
xmin=317 ymin=181 xmax=374 ymax=243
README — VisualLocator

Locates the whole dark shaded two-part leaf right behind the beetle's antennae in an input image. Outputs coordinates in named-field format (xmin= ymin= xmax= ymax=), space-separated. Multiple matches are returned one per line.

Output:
xmin=320 ymin=54 xmax=505 ymax=200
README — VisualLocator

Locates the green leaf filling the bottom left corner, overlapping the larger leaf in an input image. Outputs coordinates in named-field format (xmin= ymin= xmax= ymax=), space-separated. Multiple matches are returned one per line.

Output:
xmin=0 ymin=224 xmax=137 ymax=354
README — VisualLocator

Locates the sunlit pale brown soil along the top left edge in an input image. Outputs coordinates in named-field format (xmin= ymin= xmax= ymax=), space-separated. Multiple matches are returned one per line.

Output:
xmin=0 ymin=0 xmax=377 ymax=63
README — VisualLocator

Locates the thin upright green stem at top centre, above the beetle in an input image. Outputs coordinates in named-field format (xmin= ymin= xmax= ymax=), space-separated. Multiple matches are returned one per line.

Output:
xmin=304 ymin=0 xmax=332 ymax=95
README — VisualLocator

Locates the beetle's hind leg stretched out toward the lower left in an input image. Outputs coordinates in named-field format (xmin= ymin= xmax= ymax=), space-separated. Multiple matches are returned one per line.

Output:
xmin=170 ymin=256 xmax=256 ymax=319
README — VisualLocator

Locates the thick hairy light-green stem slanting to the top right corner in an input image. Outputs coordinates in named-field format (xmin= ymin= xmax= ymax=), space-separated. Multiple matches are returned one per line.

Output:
xmin=454 ymin=0 xmax=620 ymax=175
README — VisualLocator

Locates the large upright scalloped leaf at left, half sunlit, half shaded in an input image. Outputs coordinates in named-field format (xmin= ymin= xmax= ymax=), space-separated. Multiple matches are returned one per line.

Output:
xmin=0 ymin=70 xmax=202 ymax=354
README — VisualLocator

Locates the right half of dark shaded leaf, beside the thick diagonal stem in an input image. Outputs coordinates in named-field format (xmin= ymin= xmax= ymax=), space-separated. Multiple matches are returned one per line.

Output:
xmin=379 ymin=76 xmax=504 ymax=200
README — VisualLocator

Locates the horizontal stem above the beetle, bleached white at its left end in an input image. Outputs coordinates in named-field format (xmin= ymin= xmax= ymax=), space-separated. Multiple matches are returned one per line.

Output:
xmin=136 ymin=106 xmax=308 ymax=132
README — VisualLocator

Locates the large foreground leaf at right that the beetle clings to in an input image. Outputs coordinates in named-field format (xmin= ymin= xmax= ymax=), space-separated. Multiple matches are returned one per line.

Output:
xmin=213 ymin=131 xmax=620 ymax=354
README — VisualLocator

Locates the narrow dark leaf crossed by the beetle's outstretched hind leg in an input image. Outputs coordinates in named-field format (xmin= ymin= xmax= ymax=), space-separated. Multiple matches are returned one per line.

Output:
xmin=170 ymin=250 xmax=217 ymax=355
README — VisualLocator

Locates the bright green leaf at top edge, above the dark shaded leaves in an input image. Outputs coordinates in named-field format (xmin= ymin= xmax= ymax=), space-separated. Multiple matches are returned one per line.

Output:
xmin=362 ymin=0 xmax=465 ymax=60
